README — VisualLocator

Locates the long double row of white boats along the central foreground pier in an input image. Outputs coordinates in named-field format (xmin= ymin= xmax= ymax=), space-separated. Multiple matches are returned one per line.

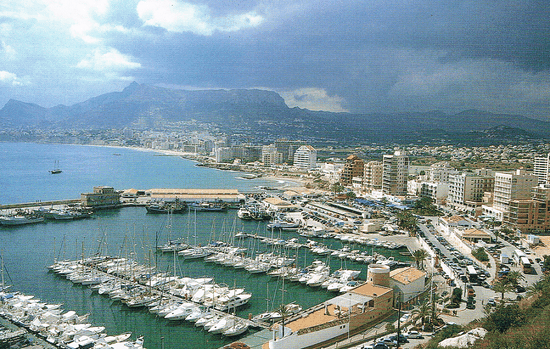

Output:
xmin=49 ymin=257 xmax=252 ymax=336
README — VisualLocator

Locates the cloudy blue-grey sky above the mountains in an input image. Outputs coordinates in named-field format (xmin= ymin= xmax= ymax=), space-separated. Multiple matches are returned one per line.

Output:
xmin=0 ymin=0 xmax=550 ymax=117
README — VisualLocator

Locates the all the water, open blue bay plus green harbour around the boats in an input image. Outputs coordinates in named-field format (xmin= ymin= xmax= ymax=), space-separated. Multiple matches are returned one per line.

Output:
xmin=0 ymin=143 xmax=407 ymax=349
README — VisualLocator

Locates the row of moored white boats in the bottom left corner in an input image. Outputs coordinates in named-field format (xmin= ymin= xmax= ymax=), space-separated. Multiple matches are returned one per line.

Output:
xmin=0 ymin=290 xmax=143 ymax=349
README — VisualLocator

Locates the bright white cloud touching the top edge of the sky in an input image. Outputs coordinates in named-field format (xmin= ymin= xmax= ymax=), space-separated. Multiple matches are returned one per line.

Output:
xmin=137 ymin=0 xmax=263 ymax=36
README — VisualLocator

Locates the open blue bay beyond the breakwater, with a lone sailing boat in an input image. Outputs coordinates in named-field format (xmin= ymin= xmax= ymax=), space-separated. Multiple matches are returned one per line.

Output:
xmin=0 ymin=143 xmax=294 ymax=204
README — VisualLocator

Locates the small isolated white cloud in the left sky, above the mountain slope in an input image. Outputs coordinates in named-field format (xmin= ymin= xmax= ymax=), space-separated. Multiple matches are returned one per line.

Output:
xmin=77 ymin=48 xmax=141 ymax=72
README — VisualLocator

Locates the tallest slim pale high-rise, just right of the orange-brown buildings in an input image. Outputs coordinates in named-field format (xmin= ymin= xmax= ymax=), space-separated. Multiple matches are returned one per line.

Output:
xmin=382 ymin=151 xmax=409 ymax=196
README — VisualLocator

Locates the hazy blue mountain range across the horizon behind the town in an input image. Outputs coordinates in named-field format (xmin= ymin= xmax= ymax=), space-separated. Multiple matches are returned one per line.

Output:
xmin=0 ymin=82 xmax=550 ymax=144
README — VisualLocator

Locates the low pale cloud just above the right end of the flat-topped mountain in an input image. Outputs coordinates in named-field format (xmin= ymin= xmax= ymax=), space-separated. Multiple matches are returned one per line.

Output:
xmin=280 ymin=88 xmax=347 ymax=112
